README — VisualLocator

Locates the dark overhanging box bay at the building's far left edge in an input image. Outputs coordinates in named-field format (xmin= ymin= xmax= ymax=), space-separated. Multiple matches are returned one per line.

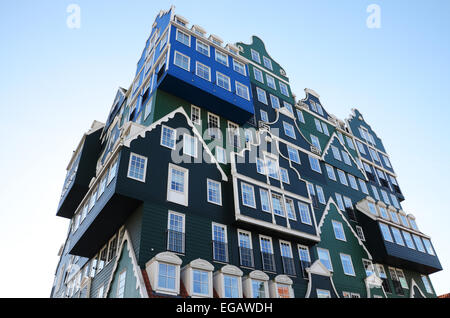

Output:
xmin=56 ymin=122 xmax=103 ymax=219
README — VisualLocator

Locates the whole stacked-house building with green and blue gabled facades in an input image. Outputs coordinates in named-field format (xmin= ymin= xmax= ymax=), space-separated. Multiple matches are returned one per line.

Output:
xmin=51 ymin=7 xmax=442 ymax=298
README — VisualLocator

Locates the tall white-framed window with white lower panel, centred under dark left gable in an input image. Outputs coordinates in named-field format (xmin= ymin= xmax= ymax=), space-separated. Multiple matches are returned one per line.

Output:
xmin=167 ymin=164 xmax=189 ymax=206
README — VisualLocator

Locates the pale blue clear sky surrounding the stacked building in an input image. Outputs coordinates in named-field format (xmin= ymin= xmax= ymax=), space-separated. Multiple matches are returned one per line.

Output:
xmin=0 ymin=0 xmax=450 ymax=297
